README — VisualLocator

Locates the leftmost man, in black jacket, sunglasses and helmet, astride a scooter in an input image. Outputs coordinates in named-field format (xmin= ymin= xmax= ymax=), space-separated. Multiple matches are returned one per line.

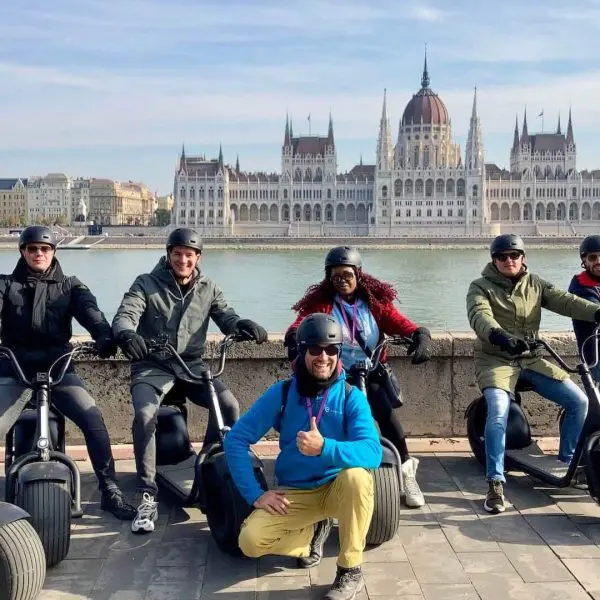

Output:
xmin=0 ymin=225 xmax=135 ymax=520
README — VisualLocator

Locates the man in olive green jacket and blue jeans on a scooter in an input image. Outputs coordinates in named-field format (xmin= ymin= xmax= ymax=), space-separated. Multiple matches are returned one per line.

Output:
xmin=467 ymin=234 xmax=600 ymax=513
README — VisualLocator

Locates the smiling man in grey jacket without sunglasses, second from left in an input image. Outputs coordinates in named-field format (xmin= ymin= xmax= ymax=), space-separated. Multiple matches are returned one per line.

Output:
xmin=112 ymin=228 xmax=267 ymax=533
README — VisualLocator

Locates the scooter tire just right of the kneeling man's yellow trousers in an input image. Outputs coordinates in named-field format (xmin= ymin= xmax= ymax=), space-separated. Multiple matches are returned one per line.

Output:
xmin=367 ymin=464 xmax=401 ymax=546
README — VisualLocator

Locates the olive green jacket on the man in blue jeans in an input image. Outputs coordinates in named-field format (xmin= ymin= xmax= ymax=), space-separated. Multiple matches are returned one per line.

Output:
xmin=467 ymin=262 xmax=599 ymax=392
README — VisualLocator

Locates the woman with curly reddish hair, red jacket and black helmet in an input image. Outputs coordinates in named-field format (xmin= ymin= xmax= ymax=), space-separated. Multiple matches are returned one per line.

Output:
xmin=285 ymin=246 xmax=431 ymax=507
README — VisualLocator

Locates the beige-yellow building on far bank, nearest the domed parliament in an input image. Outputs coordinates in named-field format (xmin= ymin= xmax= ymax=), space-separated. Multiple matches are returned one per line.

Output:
xmin=88 ymin=178 xmax=154 ymax=225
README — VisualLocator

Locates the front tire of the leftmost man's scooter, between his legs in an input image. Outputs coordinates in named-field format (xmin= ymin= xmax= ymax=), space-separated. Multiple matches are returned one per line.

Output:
xmin=16 ymin=480 xmax=71 ymax=567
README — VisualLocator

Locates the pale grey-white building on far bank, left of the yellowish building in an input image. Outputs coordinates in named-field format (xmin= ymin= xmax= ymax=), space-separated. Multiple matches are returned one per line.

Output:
xmin=27 ymin=173 xmax=73 ymax=225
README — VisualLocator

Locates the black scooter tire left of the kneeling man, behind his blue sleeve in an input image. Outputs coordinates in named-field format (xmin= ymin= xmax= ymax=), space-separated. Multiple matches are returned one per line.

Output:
xmin=203 ymin=465 xmax=268 ymax=557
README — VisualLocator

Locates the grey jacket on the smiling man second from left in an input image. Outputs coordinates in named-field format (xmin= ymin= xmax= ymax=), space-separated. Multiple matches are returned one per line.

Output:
xmin=112 ymin=257 xmax=240 ymax=392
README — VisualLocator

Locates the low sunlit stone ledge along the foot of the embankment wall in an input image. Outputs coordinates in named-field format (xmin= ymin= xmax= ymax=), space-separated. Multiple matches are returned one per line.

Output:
xmin=0 ymin=437 xmax=559 ymax=461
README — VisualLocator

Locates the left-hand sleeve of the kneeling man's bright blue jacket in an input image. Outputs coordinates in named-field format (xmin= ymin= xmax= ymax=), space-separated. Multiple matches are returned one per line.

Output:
xmin=224 ymin=381 xmax=283 ymax=506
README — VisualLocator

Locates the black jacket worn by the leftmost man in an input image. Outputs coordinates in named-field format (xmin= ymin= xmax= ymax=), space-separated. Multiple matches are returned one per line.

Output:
xmin=0 ymin=257 xmax=112 ymax=377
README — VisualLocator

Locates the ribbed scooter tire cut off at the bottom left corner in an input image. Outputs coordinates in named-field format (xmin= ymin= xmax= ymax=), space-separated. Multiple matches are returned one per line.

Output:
xmin=0 ymin=519 xmax=46 ymax=600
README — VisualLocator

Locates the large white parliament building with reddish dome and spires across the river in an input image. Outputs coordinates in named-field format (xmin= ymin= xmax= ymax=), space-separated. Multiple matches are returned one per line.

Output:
xmin=172 ymin=57 xmax=600 ymax=237
